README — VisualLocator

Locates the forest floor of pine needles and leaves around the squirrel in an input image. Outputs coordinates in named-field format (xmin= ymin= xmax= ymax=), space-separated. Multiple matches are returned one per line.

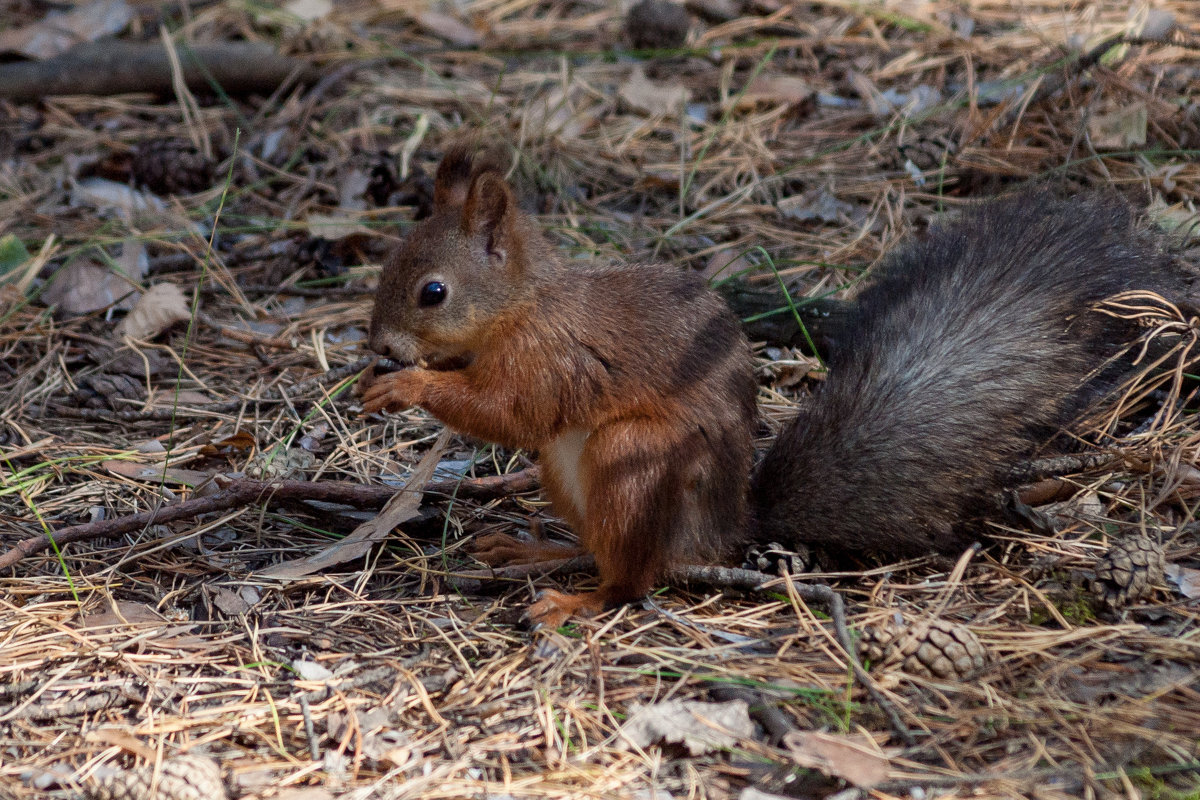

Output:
xmin=0 ymin=0 xmax=1200 ymax=800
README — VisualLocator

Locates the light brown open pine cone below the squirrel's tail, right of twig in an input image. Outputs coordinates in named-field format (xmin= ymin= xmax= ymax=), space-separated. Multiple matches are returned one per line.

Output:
xmin=858 ymin=619 xmax=988 ymax=680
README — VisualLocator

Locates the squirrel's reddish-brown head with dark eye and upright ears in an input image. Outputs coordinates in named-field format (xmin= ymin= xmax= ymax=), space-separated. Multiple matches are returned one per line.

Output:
xmin=368 ymin=144 xmax=528 ymax=365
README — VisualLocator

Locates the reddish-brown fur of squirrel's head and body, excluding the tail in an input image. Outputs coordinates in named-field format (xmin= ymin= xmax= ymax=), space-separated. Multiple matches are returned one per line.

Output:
xmin=365 ymin=142 xmax=756 ymax=624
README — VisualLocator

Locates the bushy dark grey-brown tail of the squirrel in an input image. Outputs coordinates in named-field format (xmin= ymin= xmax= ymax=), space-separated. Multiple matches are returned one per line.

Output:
xmin=752 ymin=193 xmax=1172 ymax=555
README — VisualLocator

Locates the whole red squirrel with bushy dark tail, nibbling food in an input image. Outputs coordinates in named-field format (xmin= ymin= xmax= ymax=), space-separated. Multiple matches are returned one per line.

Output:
xmin=364 ymin=144 xmax=1172 ymax=626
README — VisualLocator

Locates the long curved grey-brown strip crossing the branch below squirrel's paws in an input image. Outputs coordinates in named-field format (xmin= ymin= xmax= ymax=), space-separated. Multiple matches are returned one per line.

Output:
xmin=258 ymin=429 xmax=450 ymax=581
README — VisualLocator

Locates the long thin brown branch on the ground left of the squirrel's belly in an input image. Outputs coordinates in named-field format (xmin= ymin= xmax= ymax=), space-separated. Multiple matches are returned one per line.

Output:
xmin=0 ymin=468 xmax=538 ymax=570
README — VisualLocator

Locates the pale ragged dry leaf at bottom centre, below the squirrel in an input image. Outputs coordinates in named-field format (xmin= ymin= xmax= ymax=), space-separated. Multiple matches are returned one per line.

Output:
xmin=620 ymin=700 xmax=754 ymax=756
